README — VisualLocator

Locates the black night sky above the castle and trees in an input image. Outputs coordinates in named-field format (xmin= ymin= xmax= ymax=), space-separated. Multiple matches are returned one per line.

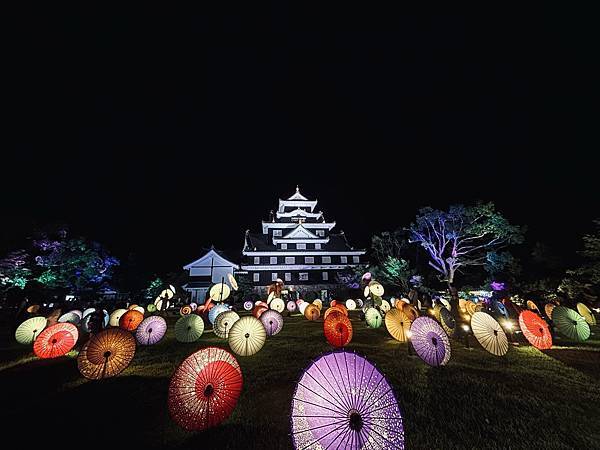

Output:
xmin=0 ymin=2 xmax=600 ymax=272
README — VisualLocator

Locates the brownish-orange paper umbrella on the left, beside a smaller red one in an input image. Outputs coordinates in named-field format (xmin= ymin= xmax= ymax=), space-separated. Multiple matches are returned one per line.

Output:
xmin=77 ymin=328 xmax=135 ymax=380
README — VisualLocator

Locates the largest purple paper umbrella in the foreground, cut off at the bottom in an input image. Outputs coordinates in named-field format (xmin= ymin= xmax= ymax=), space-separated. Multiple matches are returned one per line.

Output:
xmin=291 ymin=351 xmax=404 ymax=449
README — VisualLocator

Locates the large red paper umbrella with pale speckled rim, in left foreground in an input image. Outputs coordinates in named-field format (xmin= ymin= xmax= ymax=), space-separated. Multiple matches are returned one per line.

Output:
xmin=169 ymin=347 xmax=242 ymax=431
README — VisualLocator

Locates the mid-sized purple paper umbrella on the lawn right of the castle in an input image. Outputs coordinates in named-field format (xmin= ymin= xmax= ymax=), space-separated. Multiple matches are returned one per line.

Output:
xmin=410 ymin=316 xmax=450 ymax=366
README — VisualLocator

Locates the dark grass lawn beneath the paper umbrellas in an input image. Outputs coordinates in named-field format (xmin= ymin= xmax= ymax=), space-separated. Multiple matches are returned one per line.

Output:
xmin=0 ymin=311 xmax=600 ymax=449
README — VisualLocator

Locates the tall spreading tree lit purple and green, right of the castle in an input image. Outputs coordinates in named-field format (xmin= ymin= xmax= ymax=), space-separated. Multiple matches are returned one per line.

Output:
xmin=409 ymin=203 xmax=523 ymax=318
